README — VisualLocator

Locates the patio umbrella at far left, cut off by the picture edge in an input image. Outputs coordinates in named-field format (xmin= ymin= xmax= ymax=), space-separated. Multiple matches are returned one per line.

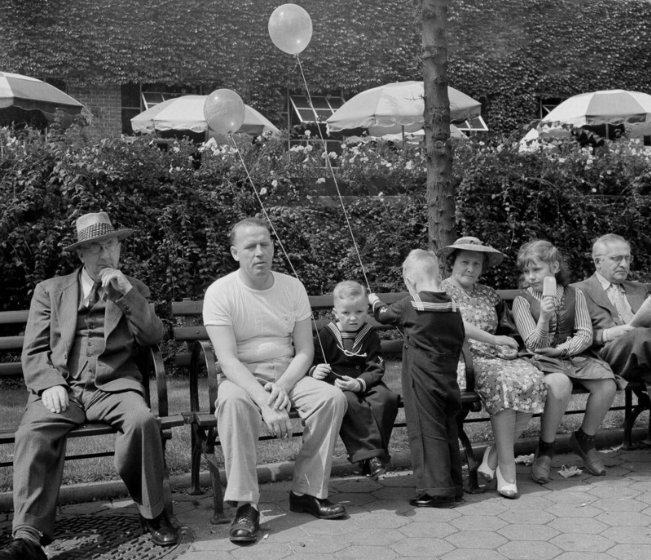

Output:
xmin=0 ymin=72 xmax=84 ymax=121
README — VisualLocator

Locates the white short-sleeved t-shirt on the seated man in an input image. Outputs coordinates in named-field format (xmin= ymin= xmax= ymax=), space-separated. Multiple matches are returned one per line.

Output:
xmin=203 ymin=270 xmax=312 ymax=381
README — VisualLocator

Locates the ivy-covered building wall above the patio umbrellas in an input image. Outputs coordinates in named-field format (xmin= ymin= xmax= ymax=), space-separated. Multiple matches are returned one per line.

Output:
xmin=0 ymin=0 xmax=651 ymax=132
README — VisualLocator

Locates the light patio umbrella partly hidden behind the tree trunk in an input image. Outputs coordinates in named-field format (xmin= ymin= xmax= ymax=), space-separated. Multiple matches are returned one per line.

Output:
xmin=326 ymin=81 xmax=481 ymax=136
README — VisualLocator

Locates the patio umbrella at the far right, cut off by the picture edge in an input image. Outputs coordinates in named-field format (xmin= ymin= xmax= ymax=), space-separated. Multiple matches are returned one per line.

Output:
xmin=541 ymin=89 xmax=651 ymax=136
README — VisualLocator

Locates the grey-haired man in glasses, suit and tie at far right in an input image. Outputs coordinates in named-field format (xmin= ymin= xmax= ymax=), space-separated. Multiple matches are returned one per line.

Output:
xmin=574 ymin=233 xmax=651 ymax=385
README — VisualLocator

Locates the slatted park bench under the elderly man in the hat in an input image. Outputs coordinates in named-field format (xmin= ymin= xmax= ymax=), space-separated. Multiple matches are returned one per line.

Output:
xmin=0 ymin=304 xmax=184 ymax=515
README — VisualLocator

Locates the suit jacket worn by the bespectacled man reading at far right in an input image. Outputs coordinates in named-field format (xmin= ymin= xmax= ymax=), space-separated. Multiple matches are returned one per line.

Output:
xmin=572 ymin=274 xmax=648 ymax=347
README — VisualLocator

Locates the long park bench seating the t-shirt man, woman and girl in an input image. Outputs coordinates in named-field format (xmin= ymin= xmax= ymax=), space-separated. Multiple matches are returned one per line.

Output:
xmin=172 ymin=290 xmax=651 ymax=523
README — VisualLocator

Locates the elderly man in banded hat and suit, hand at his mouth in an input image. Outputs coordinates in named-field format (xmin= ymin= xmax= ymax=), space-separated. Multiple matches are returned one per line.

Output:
xmin=0 ymin=212 xmax=178 ymax=560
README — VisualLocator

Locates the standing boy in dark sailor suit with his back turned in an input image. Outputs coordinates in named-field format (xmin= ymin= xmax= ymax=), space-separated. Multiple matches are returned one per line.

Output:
xmin=369 ymin=249 xmax=466 ymax=507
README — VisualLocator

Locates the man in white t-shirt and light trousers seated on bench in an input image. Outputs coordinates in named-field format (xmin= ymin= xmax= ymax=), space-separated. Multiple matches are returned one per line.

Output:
xmin=203 ymin=218 xmax=346 ymax=542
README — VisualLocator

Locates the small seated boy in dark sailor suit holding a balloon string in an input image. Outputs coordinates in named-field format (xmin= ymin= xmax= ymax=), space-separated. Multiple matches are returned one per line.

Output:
xmin=310 ymin=281 xmax=399 ymax=479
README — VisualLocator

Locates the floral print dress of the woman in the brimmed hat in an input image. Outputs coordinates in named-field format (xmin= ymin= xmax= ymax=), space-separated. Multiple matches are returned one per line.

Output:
xmin=441 ymin=280 xmax=547 ymax=415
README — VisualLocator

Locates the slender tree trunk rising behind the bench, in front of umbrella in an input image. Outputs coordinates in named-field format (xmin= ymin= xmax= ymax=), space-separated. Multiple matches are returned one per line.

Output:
xmin=422 ymin=0 xmax=456 ymax=251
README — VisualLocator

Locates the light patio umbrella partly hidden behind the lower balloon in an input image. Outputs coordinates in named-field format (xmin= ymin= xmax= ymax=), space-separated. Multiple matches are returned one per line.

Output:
xmin=131 ymin=95 xmax=280 ymax=136
